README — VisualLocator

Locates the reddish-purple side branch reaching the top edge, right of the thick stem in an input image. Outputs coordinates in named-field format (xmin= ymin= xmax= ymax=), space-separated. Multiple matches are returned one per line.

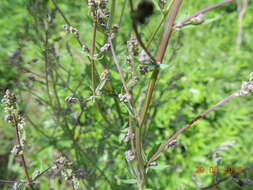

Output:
xmin=173 ymin=0 xmax=235 ymax=28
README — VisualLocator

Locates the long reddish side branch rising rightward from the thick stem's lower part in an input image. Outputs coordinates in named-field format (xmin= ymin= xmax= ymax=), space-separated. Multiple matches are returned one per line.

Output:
xmin=146 ymin=90 xmax=240 ymax=166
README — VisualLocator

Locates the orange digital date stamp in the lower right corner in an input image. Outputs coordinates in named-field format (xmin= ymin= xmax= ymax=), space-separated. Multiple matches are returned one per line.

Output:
xmin=194 ymin=166 xmax=243 ymax=174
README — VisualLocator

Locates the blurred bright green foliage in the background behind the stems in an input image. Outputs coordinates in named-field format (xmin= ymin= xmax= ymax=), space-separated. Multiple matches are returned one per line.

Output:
xmin=0 ymin=0 xmax=253 ymax=190
